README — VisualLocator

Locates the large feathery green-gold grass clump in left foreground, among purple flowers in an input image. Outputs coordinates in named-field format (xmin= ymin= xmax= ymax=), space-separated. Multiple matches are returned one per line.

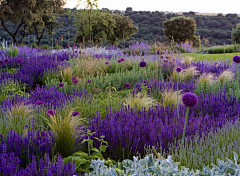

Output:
xmin=44 ymin=109 xmax=82 ymax=157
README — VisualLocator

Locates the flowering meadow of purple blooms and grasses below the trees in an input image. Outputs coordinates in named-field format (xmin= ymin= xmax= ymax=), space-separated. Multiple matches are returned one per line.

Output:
xmin=0 ymin=43 xmax=240 ymax=176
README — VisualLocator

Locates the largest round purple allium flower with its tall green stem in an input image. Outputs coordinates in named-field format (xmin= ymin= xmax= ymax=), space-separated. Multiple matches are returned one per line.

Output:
xmin=182 ymin=92 xmax=198 ymax=140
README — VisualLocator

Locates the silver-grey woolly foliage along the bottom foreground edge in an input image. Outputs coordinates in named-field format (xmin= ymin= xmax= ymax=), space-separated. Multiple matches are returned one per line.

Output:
xmin=86 ymin=152 xmax=240 ymax=176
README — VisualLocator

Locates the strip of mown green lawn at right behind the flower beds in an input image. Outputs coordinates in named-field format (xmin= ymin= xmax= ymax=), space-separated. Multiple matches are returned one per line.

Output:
xmin=183 ymin=53 xmax=240 ymax=61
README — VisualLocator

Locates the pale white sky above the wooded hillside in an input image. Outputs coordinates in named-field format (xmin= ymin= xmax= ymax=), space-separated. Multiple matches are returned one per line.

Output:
xmin=66 ymin=0 xmax=240 ymax=14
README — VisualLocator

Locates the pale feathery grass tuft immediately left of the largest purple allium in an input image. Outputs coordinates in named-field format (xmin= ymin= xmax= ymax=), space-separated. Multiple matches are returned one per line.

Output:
xmin=162 ymin=89 xmax=182 ymax=108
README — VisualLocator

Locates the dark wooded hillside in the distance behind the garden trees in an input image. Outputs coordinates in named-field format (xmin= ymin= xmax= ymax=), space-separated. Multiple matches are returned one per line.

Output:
xmin=0 ymin=8 xmax=240 ymax=46
